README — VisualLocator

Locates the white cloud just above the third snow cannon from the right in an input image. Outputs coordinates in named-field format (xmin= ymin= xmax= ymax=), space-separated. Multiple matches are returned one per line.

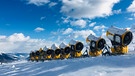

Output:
xmin=73 ymin=30 xmax=96 ymax=39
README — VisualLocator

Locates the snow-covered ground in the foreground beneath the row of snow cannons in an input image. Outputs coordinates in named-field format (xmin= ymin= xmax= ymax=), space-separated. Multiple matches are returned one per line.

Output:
xmin=0 ymin=54 xmax=135 ymax=76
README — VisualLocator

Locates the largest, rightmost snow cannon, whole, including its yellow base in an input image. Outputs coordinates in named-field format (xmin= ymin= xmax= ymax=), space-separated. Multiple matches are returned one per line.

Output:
xmin=106 ymin=26 xmax=133 ymax=54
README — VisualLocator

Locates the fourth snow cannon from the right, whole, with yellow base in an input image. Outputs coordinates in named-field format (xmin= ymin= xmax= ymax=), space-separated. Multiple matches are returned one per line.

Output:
xmin=59 ymin=42 xmax=71 ymax=58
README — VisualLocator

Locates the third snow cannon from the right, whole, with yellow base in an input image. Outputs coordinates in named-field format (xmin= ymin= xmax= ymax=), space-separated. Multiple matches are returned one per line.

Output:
xmin=69 ymin=39 xmax=84 ymax=57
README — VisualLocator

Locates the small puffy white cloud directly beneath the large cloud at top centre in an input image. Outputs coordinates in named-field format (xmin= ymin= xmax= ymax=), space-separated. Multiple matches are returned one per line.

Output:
xmin=70 ymin=19 xmax=87 ymax=28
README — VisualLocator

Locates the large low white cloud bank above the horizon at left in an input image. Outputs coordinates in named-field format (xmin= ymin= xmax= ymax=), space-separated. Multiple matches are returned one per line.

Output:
xmin=0 ymin=33 xmax=52 ymax=53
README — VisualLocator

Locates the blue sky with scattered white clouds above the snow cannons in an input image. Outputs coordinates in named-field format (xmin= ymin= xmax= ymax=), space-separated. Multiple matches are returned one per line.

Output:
xmin=0 ymin=0 xmax=135 ymax=52
